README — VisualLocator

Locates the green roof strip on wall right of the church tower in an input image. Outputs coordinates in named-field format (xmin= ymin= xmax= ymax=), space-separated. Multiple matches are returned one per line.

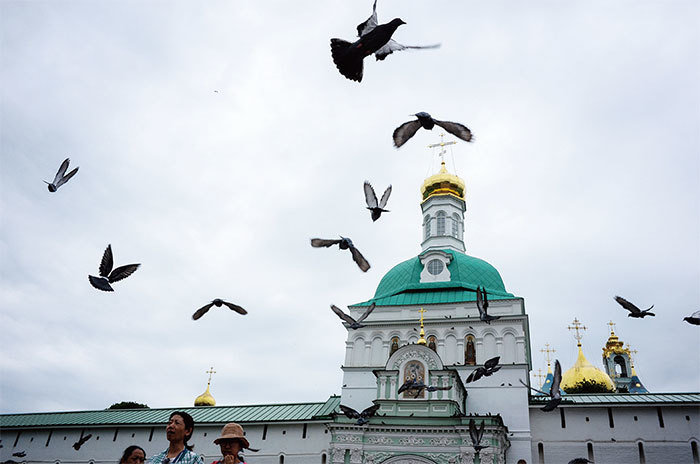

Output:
xmin=530 ymin=393 xmax=700 ymax=406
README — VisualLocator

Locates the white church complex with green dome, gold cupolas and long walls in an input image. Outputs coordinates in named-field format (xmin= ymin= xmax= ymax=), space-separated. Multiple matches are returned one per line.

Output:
xmin=0 ymin=158 xmax=700 ymax=464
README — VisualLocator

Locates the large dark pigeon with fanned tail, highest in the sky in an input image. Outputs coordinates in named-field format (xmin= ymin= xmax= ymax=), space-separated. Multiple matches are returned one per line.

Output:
xmin=331 ymin=0 xmax=440 ymax=82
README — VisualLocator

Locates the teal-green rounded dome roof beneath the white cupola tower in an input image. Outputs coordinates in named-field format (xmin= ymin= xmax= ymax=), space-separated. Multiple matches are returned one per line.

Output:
xmin=353 ymin=250 xmax=517 ymax=306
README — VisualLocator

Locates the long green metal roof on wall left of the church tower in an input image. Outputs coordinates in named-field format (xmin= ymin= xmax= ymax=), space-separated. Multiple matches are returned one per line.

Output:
xmin=0 ymin=396 xmax=340 ymax=428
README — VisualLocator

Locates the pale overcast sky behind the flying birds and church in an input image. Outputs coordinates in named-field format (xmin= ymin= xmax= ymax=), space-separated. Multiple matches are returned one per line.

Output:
xmin=0 ymin=0 xmax=700 ymax=412
